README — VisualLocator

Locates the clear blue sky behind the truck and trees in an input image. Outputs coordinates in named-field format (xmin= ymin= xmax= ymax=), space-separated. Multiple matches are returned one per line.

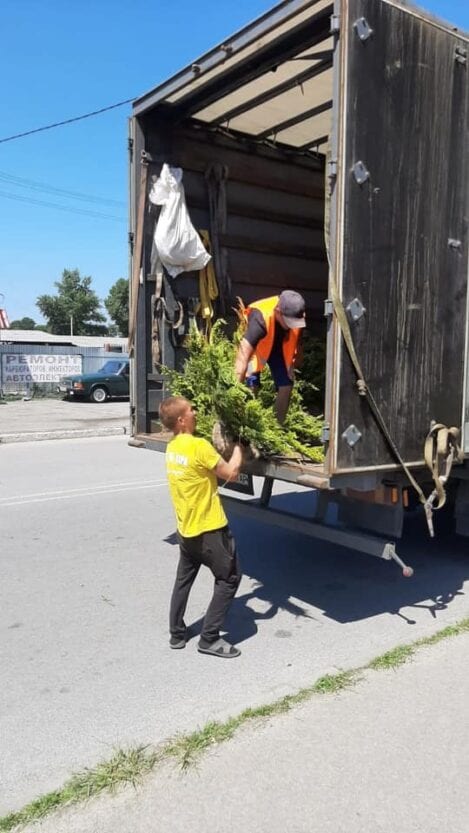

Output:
xmin=0 ymin=0 xmax=469 ymax=321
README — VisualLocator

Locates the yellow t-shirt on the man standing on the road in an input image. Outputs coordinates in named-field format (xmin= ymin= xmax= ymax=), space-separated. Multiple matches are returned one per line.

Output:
xmin=166 ymin=434 xmax=228 ymax=538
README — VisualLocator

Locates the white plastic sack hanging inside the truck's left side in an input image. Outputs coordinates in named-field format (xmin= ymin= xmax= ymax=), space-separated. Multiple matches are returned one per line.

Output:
xmin=150 ymin=163 xmax=210 ymax=278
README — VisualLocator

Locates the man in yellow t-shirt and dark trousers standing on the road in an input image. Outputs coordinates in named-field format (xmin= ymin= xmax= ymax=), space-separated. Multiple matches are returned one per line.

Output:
xmin=160 ymin=396 xmax=242 ymax=658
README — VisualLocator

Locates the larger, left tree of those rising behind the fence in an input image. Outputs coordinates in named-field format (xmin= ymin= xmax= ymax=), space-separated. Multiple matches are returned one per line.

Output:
xmin=36 ymin=269 xmax=107 ymax=335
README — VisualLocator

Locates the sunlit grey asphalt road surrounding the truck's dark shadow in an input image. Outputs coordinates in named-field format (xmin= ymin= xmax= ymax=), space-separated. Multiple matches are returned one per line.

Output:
xmin=0 ymin=437 xmax=469 ymax=813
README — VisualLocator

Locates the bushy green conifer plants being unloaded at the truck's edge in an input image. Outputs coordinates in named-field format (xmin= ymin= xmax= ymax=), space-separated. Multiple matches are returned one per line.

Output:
xmin=164 ymin=320 xmax=323 ymax=461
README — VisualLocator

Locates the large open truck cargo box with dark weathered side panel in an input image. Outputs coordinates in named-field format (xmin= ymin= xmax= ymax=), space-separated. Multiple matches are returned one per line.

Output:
xmin=129 ymin=0 xmax=469 ymax=563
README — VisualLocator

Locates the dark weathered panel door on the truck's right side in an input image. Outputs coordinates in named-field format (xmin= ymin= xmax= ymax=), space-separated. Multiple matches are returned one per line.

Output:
xmin=329 ymin=0 xmax=469 ymax=480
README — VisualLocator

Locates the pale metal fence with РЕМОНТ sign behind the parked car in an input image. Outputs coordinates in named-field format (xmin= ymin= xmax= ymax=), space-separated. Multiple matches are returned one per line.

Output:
xmin=0 ymin=344 xmax=128 ymax=396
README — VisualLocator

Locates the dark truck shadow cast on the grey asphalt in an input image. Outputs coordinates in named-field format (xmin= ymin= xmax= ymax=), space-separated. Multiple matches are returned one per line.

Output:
xmin=165 ymin=492 xmax=469 ymax=644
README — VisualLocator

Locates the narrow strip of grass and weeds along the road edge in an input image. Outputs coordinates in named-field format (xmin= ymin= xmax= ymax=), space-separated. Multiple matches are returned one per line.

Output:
xmin=0 ymin=618 xmax=469 ymax=833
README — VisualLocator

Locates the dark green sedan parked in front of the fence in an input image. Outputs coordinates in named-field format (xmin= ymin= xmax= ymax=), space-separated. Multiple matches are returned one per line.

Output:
xmin=59 ymin=359 xmax=129 ymax=403
